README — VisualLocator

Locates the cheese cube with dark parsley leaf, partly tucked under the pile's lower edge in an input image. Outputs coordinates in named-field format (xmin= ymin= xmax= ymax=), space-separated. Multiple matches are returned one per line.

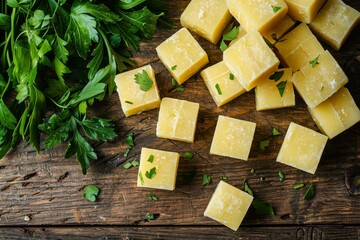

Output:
xmin=255 ymin=68 xmax=295 ymax=111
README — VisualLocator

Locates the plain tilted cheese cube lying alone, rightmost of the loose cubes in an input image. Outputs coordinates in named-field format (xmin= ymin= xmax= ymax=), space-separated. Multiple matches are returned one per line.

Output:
xmin=276 ymin=123 xmax=328 ymax=174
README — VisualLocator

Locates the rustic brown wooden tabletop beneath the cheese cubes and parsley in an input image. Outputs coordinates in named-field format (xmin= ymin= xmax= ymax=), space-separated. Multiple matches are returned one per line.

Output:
xmin=0 ymin=0 xmax=360 ymax=240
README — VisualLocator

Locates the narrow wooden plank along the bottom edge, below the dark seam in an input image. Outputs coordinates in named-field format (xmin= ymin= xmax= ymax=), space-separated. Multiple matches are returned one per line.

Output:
xmin=0 ymin=225 xmax=360 ymax=240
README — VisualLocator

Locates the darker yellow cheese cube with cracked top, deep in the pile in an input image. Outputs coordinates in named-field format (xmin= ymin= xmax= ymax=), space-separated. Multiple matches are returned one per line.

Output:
xmin=275 ymin=23 xmax=324 ymax=72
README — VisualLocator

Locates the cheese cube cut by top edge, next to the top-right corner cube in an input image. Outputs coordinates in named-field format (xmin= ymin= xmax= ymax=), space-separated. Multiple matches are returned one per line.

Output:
xmin=284 ymin=0 xmax=326 ymax=23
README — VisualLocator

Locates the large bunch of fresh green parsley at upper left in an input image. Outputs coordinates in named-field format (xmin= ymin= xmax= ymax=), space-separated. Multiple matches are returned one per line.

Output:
xmin=0 ymin=0 xmax=172 ymax=174
